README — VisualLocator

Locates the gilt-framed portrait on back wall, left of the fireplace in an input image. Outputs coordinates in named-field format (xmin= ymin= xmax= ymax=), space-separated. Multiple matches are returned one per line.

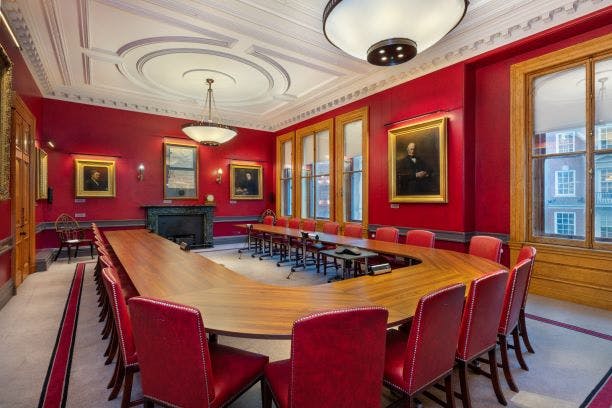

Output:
xmin=74 ymin=159 xmax=115 ymax=198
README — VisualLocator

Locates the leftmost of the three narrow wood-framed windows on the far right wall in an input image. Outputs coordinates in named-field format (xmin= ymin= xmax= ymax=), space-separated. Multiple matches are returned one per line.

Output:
xmin=276 ymin=132 xmax=294 ymax=217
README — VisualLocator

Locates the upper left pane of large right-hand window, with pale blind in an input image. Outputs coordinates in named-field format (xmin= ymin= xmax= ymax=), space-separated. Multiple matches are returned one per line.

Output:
xmin=532 ymin=66 xmax=586 ymax=155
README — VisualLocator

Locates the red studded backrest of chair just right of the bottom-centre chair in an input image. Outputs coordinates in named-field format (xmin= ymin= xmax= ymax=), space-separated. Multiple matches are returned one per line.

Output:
xmin=403 ymin=283 xmax=465 ymax=394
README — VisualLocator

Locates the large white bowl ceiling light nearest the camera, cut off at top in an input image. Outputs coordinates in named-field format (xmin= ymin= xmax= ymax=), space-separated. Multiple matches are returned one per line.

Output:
xmin=323 ymin=0 xmax=468 ymax=66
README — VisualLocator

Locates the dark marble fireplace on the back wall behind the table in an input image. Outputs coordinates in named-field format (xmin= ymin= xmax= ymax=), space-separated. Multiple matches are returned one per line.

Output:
xmin=144 ymin=205 xmax=215 ymax=248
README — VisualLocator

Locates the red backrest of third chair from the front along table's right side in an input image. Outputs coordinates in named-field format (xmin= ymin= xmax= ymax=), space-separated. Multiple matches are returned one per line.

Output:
xmin=498 ymin=259 xmax=531 ymax=335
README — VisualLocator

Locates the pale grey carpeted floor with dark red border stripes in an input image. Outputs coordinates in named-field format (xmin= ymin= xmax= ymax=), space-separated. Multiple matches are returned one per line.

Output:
xmin=0 ymin=248 xmax=612 ymax=408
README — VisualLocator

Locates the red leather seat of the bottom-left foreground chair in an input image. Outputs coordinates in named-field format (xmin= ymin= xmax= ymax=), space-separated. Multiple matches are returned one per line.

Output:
xmin=208 ymin=343 xmax=268 ymax=407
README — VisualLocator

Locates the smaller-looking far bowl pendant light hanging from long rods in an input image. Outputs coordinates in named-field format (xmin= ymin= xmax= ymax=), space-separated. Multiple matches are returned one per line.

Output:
xmin=182 ymin=78 xmax=238 ymax=146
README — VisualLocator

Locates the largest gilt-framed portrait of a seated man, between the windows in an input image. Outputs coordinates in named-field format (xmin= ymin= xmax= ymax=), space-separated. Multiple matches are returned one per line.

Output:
xmin=388 ymin=118 xmax=448 ymax=203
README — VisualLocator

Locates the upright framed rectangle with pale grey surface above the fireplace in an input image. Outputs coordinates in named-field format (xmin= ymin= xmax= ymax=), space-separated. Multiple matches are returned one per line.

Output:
xmin=164 ymin=143 xmax=198 ymax=200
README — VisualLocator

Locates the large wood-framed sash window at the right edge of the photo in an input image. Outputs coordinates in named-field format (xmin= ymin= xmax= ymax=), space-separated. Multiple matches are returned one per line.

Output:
xmin=511 ymin=42 xmax=612 ymax=250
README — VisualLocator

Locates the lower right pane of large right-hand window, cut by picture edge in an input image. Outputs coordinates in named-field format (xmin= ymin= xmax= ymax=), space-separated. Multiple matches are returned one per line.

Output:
xmin=594 ymin=154 xmax=612 ymax=242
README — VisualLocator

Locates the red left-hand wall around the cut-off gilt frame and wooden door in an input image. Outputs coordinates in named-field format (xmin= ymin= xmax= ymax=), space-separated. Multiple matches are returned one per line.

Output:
xmin=0 ymin=23 xmax=42 ymax=287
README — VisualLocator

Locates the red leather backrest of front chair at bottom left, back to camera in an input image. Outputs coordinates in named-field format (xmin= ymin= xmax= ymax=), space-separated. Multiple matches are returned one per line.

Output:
xmin=129 ymin=296 xmax=215 ymax=407
